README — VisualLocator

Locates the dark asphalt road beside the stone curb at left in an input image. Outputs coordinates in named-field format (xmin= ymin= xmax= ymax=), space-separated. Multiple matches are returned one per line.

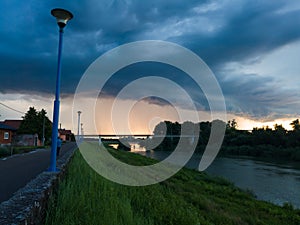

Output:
xmin=0 ymin=143 xmax=76 ymax=203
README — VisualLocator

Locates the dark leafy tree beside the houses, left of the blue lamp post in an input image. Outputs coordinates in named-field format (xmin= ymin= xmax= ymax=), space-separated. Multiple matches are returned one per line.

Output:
xmin=18 ymin=107 xmax=52 ymax=143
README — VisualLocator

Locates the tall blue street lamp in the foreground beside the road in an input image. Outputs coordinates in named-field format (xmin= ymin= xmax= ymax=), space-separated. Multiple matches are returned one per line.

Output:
xmin=49 ymin=8 xmax=73 ymax=172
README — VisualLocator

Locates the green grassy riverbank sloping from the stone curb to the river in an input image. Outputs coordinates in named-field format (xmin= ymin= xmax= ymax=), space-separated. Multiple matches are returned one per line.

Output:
xmin=45 ymin=147 xmax=300 ymax=225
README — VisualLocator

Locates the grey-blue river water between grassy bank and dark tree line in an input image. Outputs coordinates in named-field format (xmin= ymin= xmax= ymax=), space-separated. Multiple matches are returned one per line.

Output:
xmin=137 ymin=151 xmax=300 ymax=209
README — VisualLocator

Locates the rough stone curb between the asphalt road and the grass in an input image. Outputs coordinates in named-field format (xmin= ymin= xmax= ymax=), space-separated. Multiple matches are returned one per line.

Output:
xmin=0 ymin=145 xmax=77 ymax=225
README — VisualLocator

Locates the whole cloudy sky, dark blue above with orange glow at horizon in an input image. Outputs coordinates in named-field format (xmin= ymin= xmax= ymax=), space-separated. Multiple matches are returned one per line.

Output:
xmin=0 ymin=0 xmax=300 ymax=132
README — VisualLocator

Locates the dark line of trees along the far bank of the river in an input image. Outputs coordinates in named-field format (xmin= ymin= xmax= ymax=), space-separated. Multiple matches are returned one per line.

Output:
xmin=153 ymin=119 xmax=300 ymax=161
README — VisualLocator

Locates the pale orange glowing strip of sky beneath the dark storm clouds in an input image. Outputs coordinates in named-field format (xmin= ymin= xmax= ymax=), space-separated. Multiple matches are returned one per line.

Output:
xmin=0 ymin=94 xmax=296 ymax=134
